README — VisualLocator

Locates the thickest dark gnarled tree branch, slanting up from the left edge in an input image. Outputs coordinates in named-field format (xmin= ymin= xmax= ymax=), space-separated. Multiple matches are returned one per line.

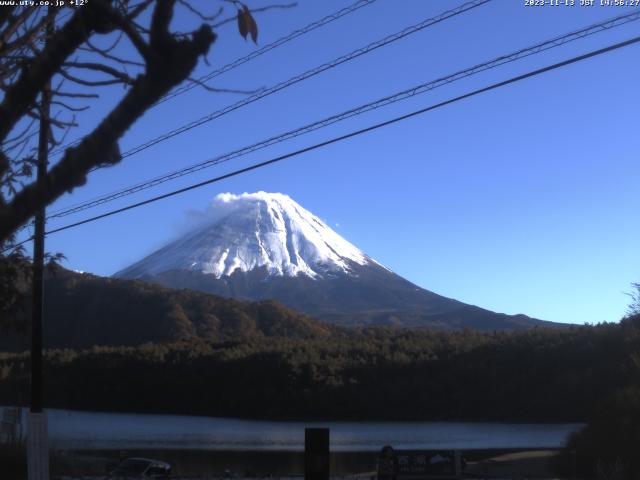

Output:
xmin=0 ymin=0 xmax=215 ymax=242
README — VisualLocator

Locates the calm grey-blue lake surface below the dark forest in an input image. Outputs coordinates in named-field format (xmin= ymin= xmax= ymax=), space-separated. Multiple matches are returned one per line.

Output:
xmin=5 ymin=407 xmax=583 ymax=452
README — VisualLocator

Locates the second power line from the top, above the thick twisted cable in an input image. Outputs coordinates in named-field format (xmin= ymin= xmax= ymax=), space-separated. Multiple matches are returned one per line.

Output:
xmin=50 ymin=0 xmax=492 ymax=167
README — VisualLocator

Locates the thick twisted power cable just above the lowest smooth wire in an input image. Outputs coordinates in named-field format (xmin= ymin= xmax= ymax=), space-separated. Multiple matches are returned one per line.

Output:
xmin=48 ymin=10 xmax=640 ymax=219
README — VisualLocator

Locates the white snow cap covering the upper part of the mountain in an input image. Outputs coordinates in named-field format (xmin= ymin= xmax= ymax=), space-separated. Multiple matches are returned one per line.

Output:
xmin=116 ymin=192 xmax=373 ymax=278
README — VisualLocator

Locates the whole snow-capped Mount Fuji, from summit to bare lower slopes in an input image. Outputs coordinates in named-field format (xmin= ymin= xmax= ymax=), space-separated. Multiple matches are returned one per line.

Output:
xmin=115 ymin=192 xmax=553 ymax=330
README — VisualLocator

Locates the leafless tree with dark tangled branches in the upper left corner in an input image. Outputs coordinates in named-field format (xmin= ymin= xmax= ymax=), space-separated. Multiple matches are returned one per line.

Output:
xmin=0 ymin=0 xmax=282 ymax=245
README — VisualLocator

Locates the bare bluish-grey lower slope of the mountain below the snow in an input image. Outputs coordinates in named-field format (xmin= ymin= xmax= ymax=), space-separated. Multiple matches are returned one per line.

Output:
xmin=140 ymin=267 xmax=544 ymax=330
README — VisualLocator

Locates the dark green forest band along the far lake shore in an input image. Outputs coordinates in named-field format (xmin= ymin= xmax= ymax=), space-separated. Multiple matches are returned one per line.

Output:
xmin=0 ymin=316 xmax=640 ymax=421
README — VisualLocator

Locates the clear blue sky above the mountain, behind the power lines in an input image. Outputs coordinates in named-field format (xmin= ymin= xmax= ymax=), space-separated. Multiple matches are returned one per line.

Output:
xmin=17 ymin=0 xmax=640 ymax=323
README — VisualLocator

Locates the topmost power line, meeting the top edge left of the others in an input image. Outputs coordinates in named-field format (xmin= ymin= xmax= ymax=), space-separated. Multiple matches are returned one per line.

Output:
xmin=51 ymin=0 xmax=377 ymax=155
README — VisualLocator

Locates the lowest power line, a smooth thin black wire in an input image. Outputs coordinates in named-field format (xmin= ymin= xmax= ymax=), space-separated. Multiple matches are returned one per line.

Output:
xmin=32 ymin=36 xmax=640 ymax=240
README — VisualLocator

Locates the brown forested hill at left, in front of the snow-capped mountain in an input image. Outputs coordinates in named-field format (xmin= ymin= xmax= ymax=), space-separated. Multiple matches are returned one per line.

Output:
xmin=0 ymin=268 xmax=336 ymax=351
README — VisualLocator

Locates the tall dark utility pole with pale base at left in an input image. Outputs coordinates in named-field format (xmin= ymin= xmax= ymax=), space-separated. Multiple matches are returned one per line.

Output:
xmin=27 ymin=7 xmax=54 ymax=480
